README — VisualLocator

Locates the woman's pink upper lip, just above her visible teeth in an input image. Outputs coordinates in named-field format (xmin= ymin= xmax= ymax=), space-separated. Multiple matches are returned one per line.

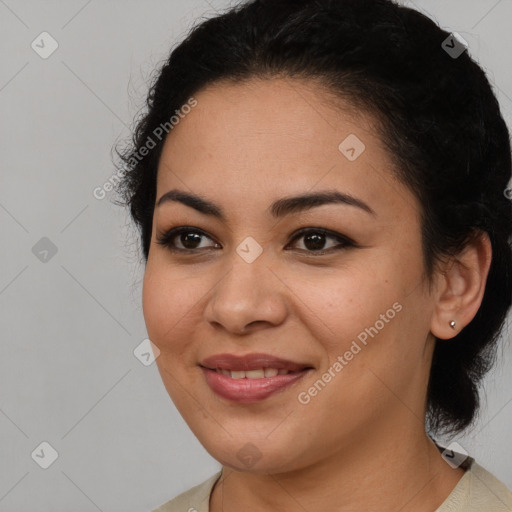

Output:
xmin=200 ymin=354 xmax=312 ymax=372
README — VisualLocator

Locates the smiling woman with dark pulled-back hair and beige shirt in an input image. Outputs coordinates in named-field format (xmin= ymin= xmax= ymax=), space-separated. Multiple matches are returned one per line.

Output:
xmin=115 ymin=0 xmax=512 ymax=512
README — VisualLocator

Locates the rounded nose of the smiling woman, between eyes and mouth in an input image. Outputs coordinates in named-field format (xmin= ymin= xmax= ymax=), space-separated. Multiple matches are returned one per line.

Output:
xmin=204 ymin=253 xmax=287 ymax=334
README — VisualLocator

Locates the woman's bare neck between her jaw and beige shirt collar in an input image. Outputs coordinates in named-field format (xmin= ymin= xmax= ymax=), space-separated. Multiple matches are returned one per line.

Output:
xmin=210 ymin=420 xmax=464 ymax=512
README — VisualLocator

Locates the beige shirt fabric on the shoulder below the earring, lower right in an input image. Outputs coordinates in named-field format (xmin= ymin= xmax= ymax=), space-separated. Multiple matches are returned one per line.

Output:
xmin=436 ymin=460 xmax=512 ymax=512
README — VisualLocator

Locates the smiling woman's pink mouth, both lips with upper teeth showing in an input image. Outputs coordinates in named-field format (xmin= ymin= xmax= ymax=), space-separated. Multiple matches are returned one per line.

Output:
xmin=200 ymin=354 xmax=312 ymax=403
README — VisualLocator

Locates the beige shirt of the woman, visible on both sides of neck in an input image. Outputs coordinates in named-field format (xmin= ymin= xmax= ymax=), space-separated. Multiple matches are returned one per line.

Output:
xmin=152 ymin=458 xmax=512 ymax=512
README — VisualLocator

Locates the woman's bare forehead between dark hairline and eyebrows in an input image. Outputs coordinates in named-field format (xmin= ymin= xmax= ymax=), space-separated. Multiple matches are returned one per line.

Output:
xmin=157 ymin=79 xmax=417 ymax=222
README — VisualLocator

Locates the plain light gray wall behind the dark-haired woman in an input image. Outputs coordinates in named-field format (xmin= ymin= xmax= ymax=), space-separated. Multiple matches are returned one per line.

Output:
xmin=0 ymin=0 xmax=512 ymax=512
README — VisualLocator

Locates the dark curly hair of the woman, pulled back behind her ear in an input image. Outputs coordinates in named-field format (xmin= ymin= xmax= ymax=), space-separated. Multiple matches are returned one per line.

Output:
xmin=114 ymin=0 xmax=512 ymax=432
